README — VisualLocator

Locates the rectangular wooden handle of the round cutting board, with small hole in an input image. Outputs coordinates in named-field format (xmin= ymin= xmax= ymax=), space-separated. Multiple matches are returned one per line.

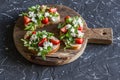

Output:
xmin=86 ymin=28 xmax=113 ymax=44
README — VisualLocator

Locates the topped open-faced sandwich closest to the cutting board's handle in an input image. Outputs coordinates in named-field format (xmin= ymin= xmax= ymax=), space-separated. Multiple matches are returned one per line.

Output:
xmin=58 ymin=16 xmax=84 ymax=50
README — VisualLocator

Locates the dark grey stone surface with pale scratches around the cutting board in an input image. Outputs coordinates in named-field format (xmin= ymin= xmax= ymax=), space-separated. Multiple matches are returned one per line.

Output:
xmin=0 ymin=0 xmax=120 ymax=80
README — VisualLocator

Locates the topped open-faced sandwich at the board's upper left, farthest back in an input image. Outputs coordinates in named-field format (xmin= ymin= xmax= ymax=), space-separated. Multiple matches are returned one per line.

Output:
xmin=20 ymin=5 xmax=60 ymax=31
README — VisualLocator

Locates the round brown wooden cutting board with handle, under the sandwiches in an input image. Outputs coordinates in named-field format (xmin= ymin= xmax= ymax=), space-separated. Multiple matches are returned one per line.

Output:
xmin=13 ymin=5 xmax=113 ymax=65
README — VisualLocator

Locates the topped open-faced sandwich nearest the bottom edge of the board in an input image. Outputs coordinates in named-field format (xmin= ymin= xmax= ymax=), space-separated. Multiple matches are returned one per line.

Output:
xmin=21 ymin=31 xmax=60 ymax=59
